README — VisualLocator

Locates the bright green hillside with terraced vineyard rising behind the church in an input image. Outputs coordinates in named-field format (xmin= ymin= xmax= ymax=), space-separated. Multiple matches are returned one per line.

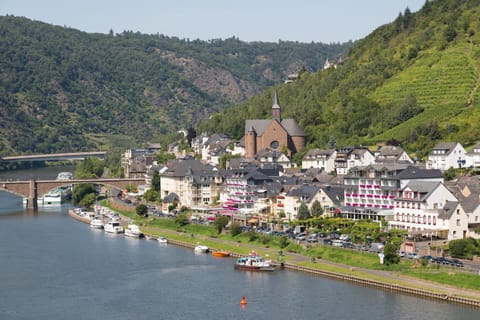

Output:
xmin=200 ymin=0 xmax=480 ymax=157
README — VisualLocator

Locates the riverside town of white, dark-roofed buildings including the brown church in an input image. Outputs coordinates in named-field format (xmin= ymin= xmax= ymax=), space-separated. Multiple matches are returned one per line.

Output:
xmin=123 ymin=92 xmax=480 ymax=253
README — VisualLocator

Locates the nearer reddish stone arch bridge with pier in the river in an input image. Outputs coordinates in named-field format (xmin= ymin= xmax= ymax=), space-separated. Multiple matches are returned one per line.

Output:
xmin=0 ymin=178 xmax=145 ymax=209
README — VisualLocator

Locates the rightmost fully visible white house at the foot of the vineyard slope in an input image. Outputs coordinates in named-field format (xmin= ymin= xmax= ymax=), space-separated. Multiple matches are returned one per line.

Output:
xmin=427 ymin=142 xmax=467 ymax=171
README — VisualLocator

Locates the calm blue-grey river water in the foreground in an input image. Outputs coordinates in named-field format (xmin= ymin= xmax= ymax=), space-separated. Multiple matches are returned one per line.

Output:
xmin=0 ymin=166 xmax=480 ymax=320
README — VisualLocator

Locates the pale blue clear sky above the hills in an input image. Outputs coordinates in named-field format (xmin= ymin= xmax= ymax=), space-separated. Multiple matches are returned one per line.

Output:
xmin=0 ymin=0 xmax=426 ymax=43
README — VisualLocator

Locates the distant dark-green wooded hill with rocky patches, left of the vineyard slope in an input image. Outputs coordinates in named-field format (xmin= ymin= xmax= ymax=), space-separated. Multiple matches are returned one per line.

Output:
xmin=0 ymin=16 xmax=351 ymax=155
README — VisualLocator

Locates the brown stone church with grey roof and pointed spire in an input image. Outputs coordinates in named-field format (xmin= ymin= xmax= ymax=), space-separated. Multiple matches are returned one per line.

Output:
xmin=244 ymin=90 xmax=306 ymax=159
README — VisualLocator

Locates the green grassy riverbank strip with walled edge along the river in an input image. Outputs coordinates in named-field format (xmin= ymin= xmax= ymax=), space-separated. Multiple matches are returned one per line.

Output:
xmin=68 ymin=206 xmax=480 ymax=308
